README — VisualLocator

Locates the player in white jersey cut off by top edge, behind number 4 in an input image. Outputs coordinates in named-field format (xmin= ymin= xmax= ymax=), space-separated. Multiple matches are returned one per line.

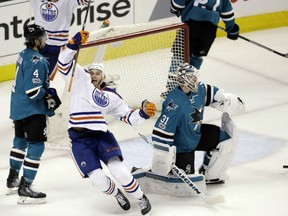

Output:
xmin=30 ymin=0 xmax=89 ymax=77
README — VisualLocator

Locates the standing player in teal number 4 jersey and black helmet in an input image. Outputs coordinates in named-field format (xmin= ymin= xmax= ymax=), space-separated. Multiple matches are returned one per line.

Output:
xmin=7 ymin=24 xmax=61 ymax=204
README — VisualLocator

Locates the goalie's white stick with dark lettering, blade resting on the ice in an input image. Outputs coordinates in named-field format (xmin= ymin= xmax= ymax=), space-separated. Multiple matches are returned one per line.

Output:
xmin=131 ymin=125 xmax=225 ymax=205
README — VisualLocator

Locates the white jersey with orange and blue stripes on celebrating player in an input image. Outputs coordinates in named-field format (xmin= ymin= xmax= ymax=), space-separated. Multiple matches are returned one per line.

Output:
xmin=57 ymin=47 xmax=143 ymax=131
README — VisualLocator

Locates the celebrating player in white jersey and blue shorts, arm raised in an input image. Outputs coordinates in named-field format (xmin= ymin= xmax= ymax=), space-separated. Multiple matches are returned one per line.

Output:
xmin=58 ymin=31 xmax=156 ymax=215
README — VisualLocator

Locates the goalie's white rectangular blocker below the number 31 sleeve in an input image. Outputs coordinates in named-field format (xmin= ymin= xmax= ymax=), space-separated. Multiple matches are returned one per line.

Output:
xmin=152 ymin=143 xmax=176 ymax=175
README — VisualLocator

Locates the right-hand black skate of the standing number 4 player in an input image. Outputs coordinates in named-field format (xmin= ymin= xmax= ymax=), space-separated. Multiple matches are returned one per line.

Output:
xmin=17 ymin=177 xmax=46 ymax=204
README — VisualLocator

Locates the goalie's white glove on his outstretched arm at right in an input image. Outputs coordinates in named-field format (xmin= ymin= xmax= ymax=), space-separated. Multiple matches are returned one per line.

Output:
xmin=211 ymin=89 xmax=245 ymax=113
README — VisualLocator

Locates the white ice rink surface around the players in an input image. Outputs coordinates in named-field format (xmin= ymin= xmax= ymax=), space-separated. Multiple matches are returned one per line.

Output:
xmin=0 ymin=27 xmax=288 ymax=216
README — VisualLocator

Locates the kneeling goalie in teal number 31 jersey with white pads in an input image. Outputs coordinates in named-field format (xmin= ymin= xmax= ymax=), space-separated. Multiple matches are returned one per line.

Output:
xmin=152 ymin=63 xmax=245 ymax=183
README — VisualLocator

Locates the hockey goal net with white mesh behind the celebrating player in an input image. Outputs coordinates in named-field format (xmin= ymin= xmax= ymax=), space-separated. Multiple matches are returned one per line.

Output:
xmin=47 ymin=23 xmax=189 ymax=149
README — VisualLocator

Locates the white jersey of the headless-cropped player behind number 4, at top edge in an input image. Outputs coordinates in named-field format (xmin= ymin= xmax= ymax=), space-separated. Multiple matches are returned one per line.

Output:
xmin=31 ymin=0 xmax=88 ymax=46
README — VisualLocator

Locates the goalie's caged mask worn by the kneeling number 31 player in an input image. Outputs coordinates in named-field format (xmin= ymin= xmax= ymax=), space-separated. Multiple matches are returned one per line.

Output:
xmin=177 ymin=63 xmax=198 ymax=92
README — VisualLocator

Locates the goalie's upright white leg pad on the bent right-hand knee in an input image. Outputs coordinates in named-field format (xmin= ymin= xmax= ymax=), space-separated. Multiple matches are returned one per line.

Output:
xmin=204 ymin=113 xmax=238 ymax=180
